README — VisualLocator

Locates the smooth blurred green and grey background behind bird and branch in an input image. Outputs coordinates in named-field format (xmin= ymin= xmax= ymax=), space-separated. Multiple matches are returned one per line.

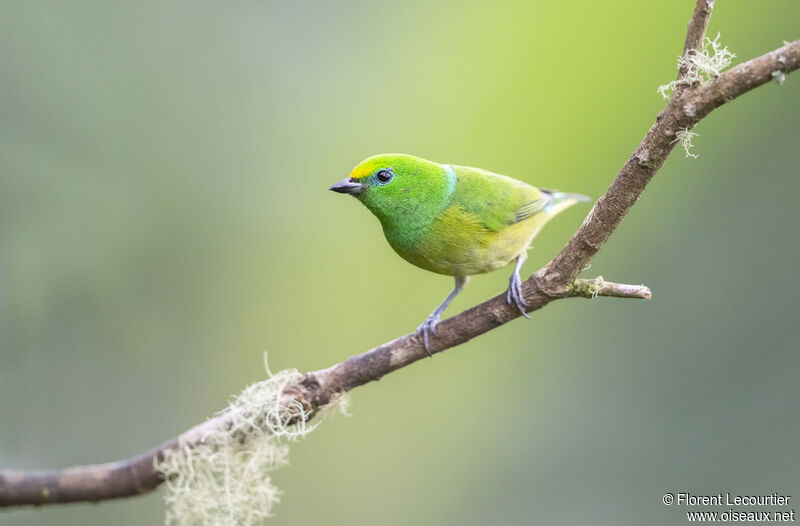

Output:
xmin=0 ymin=0 xmax=800 ymax=526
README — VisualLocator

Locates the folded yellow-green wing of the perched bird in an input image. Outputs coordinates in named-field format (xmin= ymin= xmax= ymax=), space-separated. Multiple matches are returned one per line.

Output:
xmin=451 ymin=166 xmax=552 ymax=231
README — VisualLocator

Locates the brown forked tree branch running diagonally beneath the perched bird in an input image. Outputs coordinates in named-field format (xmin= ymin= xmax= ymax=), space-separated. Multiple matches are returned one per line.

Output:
xmin=0 ymin=0 xmax=800 ymax=506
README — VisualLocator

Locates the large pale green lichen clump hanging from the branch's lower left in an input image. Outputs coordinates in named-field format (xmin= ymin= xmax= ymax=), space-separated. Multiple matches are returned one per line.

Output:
xmin=156 ymin=357 xmax=347 ymax=526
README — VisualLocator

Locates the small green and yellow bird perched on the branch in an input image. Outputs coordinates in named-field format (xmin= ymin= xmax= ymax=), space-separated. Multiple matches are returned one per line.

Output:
xmin=330 ymin=153 xmax=590 ymax=356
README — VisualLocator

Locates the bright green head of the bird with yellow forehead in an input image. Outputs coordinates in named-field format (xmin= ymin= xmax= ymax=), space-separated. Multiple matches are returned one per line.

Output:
xmin=330 ymin=154 xmax=455 ymax=224
